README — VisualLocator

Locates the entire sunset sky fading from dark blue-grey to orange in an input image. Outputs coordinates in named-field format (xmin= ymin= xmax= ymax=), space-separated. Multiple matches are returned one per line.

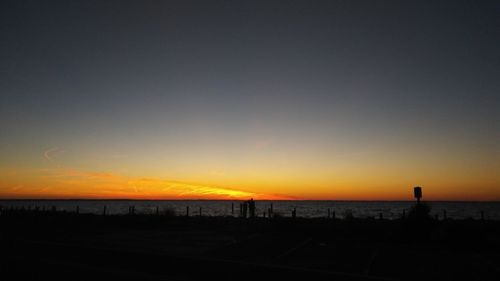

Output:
xmin=0 ymin=0 xmax=500 ymax=200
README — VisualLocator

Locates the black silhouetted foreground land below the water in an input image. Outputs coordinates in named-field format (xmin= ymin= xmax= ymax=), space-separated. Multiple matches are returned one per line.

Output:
xmin=0 ymin=211 xmax=500 ymax=281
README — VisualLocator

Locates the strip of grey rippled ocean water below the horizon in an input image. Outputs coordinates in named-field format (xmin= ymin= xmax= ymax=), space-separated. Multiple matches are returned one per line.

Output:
xmin=0 ymin=200 xmax=500 ymax=220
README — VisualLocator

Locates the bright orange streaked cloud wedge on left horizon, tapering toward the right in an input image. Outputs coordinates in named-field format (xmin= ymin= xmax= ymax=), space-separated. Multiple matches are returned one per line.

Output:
xmin=0 ymin=169 xmax=294 ymax=200
